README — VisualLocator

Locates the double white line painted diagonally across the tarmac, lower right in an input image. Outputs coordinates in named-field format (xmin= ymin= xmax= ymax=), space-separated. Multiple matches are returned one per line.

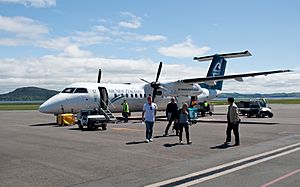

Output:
xmin=146 ymin=143 xmax=300 ymax=187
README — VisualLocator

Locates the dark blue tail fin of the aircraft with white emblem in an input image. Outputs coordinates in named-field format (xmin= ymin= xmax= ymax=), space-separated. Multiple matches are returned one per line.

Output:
xmin=200 ymin=55 xmax=227 ymax=90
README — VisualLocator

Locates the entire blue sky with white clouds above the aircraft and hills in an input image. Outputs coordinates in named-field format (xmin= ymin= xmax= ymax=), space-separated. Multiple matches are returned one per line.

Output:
xmin=0 ymin=0 xmax=300 ymax=93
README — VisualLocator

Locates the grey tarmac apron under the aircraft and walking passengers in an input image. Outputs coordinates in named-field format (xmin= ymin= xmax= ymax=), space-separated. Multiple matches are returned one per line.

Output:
xmin=0 ymin=104 xmax=300 ymax=187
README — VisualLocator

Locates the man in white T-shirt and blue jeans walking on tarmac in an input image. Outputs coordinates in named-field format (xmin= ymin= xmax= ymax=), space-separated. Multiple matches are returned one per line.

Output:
xmin=142 ymin=96 xmax=157 ymax=143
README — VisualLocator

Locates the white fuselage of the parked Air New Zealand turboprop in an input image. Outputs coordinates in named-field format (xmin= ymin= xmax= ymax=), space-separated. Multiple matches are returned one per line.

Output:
xmin=39 ymin=83 xmax=221 ymax=114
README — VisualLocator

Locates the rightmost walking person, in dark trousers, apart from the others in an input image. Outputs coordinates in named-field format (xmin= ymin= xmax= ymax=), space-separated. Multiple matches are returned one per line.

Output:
xmin=224 ymin=97 xmax=241 ymax=146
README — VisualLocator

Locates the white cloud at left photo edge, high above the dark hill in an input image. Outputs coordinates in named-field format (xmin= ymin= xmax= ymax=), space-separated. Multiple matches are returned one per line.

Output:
xmin=0 ymin=16 xmax=48 ymax=36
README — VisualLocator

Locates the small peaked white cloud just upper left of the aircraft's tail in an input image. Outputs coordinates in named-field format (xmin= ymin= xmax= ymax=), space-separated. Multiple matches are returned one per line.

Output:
xmin=158 ymin=37 xmax=210 ymax=58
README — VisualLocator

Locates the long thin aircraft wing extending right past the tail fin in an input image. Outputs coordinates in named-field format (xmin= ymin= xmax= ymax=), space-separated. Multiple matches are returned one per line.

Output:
xmin=178 ymin=69 xmax=291 ymax=83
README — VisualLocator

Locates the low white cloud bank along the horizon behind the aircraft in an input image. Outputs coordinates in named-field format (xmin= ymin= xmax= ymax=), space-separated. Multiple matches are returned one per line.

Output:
xmin=0 ymin=55 xmax=300 ymax=93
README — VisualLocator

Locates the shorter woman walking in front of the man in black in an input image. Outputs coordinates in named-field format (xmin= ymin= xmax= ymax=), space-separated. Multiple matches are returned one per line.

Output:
xmin=176 ymin=103 xmax=192 ymax=144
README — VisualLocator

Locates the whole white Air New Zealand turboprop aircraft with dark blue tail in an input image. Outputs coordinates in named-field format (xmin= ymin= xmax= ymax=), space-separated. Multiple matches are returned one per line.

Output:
xmin=39 ymin=51 xmax=290 ymax=115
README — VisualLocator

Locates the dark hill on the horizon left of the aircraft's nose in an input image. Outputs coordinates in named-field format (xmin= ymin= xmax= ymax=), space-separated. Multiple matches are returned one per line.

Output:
xmin=0 ymin=87 xmax=58 ymax=101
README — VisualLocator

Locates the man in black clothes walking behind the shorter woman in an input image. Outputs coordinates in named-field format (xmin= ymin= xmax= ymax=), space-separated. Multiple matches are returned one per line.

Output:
xmin=163 ymin=97 xmax=178 ymax=136
